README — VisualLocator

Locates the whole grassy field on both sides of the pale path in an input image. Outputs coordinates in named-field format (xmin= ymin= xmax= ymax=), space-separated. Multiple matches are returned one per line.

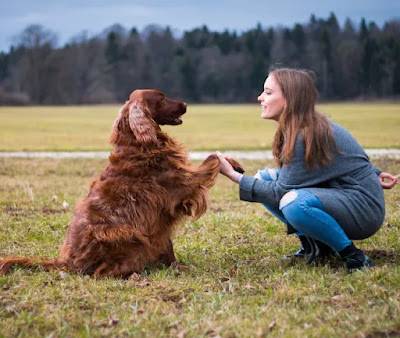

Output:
xmin=0 ymin=104 xmax=400 ymax=337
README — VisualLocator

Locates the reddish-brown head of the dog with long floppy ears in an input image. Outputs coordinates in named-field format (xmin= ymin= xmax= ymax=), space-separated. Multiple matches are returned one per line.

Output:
xmin=110 ymin=89 xmax=187 ymax=145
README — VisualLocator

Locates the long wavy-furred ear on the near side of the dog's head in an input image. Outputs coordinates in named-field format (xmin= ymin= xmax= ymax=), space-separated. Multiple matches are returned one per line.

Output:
xmin=129 ymin=101 xmax=157 ymax=143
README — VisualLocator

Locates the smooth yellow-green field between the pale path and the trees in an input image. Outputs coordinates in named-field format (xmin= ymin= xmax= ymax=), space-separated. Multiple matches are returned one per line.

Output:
xmin=0 ymin=103 xmax=400 ymax=151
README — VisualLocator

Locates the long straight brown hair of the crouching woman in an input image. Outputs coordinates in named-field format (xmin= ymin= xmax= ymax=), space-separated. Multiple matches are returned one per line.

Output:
xmin=269 ymin=68 xmax=337 ymax=168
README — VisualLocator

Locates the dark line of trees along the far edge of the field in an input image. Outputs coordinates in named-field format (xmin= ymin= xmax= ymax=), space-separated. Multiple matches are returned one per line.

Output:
xmin=0 ymin=13 xmax=400 ymax=104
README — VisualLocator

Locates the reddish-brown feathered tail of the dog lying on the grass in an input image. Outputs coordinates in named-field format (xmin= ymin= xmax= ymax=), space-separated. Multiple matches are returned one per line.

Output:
xmin=0 ymin=257 xmax=67 ymax=275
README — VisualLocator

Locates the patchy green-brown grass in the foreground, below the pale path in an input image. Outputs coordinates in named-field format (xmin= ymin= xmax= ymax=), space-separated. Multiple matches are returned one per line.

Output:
xmin=0 ymin=159 xmax=400 ymax=337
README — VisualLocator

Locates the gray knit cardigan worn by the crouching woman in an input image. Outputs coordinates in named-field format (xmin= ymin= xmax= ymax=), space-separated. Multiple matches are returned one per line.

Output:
xmin=239 ymin=121 xmax=385 ymax=239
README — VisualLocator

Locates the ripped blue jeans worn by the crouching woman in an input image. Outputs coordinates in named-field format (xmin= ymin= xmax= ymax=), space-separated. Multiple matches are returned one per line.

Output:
xmin=256 ymin=169 xmax=352 ymax=252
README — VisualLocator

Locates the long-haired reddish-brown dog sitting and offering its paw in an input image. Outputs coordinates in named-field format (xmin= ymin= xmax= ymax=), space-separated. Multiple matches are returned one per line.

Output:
xmin=0 ymin=90 xmax=243 ymax=278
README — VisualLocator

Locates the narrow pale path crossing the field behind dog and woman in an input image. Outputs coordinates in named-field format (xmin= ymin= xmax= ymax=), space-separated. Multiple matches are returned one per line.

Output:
xmin=0 ymin=149 xmax=400 ymax=160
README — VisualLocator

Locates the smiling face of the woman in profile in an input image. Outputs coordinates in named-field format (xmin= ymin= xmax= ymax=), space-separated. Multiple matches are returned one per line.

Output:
xmin=257 ymin=75 xmax=286 ymax=121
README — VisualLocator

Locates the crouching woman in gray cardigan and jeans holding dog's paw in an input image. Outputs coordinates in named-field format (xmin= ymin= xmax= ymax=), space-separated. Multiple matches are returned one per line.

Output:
xmin=218 ymin=68 xmax=397 ymax=270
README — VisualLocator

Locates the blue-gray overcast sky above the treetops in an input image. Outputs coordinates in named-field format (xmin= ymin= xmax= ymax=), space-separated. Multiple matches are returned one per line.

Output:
xmin=0 ymin=0 xmax=400 ymax=51
